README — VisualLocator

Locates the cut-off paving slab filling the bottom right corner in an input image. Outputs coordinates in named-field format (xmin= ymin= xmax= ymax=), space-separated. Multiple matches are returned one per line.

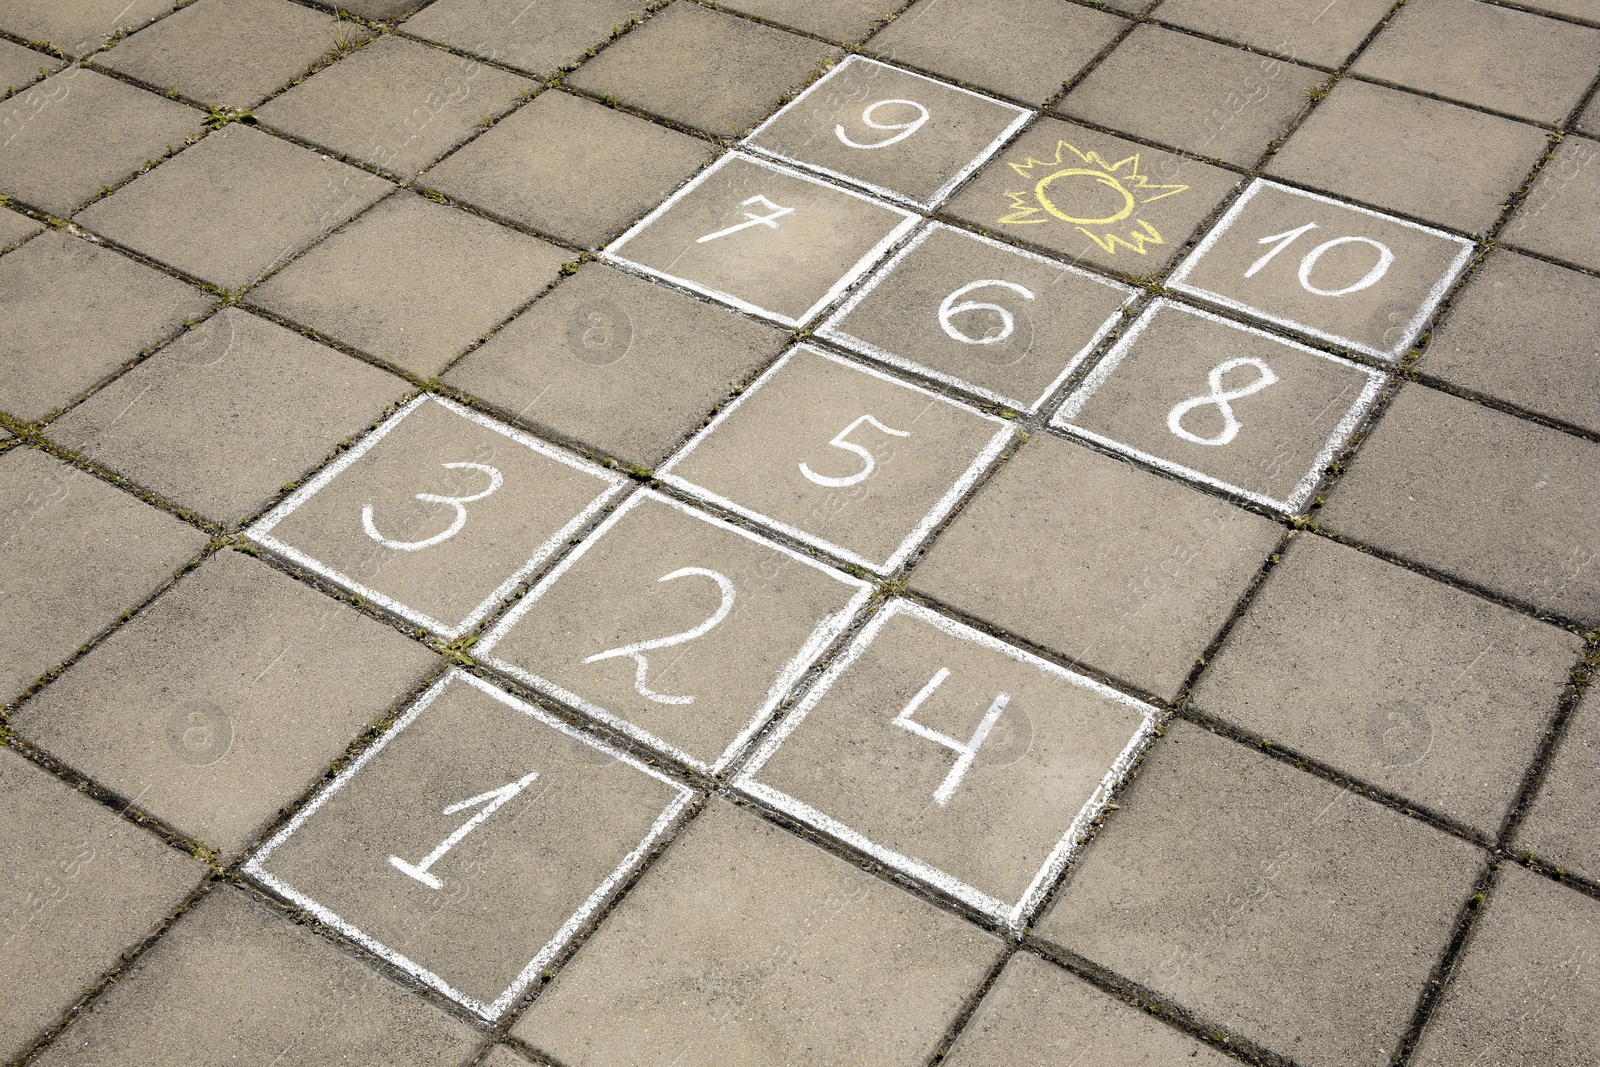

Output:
xmin=1411 ymin=864 xmax=1600 ymax=1067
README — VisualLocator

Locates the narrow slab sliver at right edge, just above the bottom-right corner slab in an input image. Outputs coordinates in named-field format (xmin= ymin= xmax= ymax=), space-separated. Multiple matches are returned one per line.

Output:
xmin=1517 ymin=694 xmax=1600 ymax=881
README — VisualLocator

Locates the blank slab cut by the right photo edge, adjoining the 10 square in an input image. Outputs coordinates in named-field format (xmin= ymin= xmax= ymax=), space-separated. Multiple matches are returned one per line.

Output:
xmin=1418 ymin=251 xmax=1600 ymax=434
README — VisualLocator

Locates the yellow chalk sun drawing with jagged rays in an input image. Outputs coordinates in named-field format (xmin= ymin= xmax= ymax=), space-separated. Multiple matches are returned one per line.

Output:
xmin=1000 ymin=141 xmax=1189 ymax=256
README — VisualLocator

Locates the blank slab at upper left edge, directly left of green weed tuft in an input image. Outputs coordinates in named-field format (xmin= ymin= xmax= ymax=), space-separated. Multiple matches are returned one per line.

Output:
xmin=0 ymin=67 xmax=205 ymax=218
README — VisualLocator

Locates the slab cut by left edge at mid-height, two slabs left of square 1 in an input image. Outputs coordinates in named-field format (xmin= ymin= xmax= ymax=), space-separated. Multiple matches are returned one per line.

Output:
xmin=0 ymin=448 xmax=206 ymax=701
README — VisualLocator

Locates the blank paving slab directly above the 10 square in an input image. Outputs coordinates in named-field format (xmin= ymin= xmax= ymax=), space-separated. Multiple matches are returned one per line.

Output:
xmin=1267 ymin=78 xmax=1547 ymax=234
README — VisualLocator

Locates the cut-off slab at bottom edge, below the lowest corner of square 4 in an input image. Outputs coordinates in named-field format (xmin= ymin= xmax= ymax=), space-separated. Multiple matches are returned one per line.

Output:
xmin=941 ymin=952 xmax=1237 ymax=1067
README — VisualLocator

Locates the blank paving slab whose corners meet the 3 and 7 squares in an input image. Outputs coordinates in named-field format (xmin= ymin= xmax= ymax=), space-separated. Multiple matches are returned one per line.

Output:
xmin=250 ymin=192 xmax=566 ymax=378
